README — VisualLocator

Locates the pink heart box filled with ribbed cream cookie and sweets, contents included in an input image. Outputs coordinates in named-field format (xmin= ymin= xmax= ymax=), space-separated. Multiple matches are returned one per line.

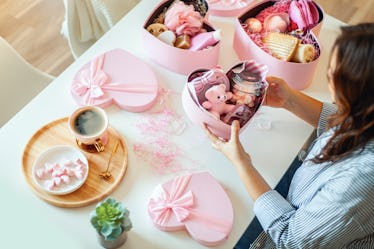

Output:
xmin=233 ymin=0 xmax=324 ymax=90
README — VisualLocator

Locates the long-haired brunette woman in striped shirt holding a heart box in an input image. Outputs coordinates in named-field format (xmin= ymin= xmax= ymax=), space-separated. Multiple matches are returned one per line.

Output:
xmin=204 ymin=23 xmax=374 ymax=249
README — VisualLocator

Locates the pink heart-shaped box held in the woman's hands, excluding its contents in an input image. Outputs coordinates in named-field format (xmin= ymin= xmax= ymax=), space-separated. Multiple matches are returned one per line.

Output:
xmin=182 ymin=60 xmax=268 ymax=140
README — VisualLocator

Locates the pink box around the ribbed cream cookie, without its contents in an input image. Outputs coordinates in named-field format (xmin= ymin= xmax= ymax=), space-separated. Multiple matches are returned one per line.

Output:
xmin=233 ymin=1 xmax=324 ymax=90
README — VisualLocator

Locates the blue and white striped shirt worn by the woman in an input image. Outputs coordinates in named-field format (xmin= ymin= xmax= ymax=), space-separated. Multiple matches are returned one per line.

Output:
xmin=250 ymin=103 xmax=374 ymax=249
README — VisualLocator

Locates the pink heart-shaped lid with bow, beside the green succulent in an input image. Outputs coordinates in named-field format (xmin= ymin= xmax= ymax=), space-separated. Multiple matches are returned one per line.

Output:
xmin=148 ymin=172 xmax=234 ymax=246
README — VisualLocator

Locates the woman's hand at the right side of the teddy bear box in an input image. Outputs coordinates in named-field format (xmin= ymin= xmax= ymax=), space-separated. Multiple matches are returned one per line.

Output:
xmin=264 ymin=76 xmax=293 ymax=108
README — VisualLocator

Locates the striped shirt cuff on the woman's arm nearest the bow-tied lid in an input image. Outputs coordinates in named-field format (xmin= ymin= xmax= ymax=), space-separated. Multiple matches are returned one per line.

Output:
xmin=253 ymin=190 xmax=295 ymax=231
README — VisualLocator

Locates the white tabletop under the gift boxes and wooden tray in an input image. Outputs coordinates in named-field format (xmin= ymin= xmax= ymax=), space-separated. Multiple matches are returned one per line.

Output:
xmin=0 ymin=0 xmax=343 ymax=249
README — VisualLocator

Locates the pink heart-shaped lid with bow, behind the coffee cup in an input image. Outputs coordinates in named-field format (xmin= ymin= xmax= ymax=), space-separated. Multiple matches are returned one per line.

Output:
xmin=71 ymin=48 xmax=158 ymax=112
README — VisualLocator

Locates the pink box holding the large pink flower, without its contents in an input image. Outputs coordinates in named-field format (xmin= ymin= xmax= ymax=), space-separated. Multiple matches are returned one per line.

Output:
xmin=142 ymin=0 xmax=220 ymax=75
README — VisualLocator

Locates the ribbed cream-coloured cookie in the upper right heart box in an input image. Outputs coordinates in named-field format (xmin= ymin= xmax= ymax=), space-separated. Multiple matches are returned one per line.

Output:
xmin=263 ymin=32 xmax=299 ymax=61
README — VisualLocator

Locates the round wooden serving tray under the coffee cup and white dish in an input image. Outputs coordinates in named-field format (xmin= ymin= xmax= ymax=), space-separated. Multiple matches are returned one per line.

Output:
xmin=22 ymin=117 xmax=128 ymax=207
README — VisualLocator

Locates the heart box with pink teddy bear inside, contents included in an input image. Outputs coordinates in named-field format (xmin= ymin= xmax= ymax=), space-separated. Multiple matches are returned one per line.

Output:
xmin=182 ymin=60 xmax=268 ymax=140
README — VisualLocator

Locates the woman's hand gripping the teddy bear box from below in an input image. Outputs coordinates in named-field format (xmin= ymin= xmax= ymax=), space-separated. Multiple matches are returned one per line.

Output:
xmin=203 ymin=120 xmax=251 ymax=165
